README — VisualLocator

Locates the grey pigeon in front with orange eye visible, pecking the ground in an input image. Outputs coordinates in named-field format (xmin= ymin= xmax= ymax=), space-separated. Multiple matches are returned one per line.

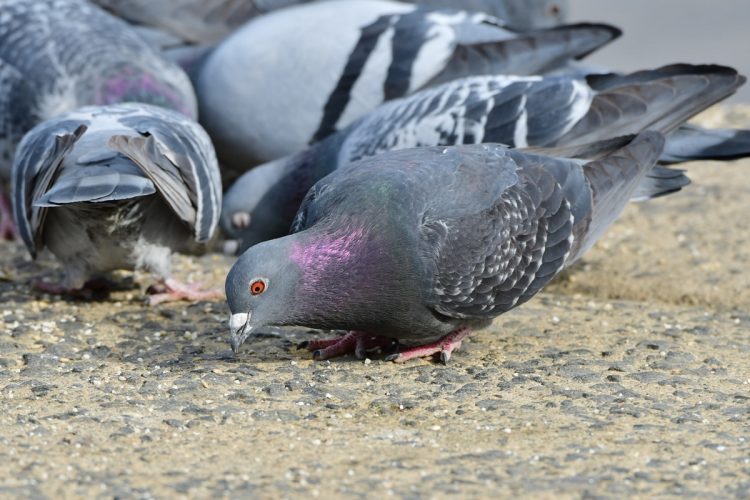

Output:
xmin=226 ymin=131 xmax=687 ymax=362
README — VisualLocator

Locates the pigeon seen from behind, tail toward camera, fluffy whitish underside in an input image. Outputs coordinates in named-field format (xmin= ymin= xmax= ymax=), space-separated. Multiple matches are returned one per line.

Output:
xmin=12 ymin=103 xmax=222 ymax=304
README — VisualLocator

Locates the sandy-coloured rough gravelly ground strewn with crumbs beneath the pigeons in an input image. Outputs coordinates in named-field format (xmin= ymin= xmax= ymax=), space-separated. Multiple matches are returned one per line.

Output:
xmin=0 ymin=106 xmax=750 ymax=498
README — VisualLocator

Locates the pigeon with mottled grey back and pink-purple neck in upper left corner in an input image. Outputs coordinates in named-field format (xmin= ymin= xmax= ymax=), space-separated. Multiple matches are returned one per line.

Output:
xmin=0 ymin=0 xmax=197 ymax=240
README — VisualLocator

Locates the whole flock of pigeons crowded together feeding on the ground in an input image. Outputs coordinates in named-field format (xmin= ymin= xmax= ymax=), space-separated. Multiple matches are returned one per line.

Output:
xmin=0 ymin=0 xmax=750 ymax=362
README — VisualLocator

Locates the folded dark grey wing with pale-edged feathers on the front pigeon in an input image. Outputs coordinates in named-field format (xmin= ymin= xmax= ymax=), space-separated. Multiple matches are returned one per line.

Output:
xmin=420 ymin=146 xmax=587 ymax=318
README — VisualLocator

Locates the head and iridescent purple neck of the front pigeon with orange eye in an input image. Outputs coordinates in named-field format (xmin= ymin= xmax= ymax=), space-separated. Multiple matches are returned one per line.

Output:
xmin=226 ymin=221 xmax=415 ymax=351
